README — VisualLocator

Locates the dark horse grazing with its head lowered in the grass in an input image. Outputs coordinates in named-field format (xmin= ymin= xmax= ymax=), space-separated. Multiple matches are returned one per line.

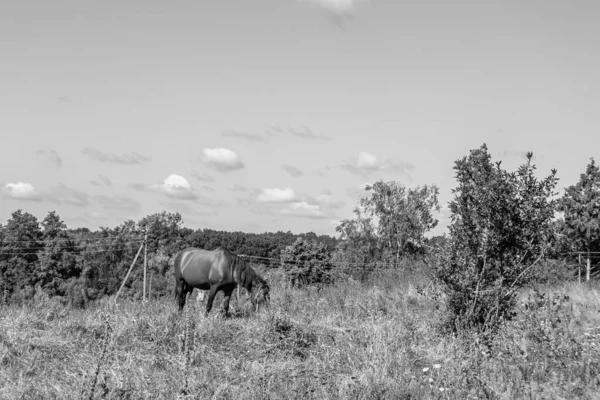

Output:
xmin=174 ymin=247 xmax=269 ymax=315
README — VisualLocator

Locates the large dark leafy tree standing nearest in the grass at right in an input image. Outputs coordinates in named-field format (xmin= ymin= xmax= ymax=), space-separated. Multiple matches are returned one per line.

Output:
xmin=435 ymin=144 xmax=558 ymax=333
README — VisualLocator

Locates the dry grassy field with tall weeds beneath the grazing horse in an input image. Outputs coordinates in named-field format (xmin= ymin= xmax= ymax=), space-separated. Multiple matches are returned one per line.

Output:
xmin=0 ymin=273 xmax=600 ymax=399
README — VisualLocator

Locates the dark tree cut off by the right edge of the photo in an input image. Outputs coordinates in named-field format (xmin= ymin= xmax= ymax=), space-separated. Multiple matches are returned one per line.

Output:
xmin=556 ymin=158 xmax=600 ymax=281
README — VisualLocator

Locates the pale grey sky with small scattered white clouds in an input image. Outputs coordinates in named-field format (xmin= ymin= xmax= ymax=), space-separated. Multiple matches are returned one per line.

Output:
xmin=0 ymin=0 xmax=600 ymax=235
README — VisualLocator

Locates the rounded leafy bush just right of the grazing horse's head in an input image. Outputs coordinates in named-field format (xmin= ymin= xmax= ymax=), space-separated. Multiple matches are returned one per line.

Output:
xmin=281 ymin=238 xmax=333 ymax=286
